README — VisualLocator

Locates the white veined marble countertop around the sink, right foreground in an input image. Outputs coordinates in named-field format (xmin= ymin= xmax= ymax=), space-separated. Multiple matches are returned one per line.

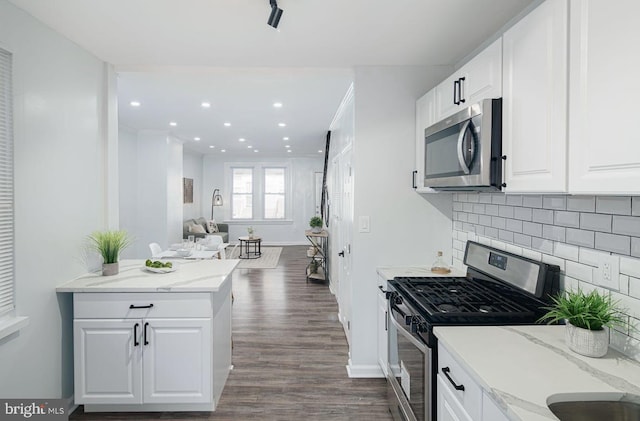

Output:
xmin=434 ymin=325 xmax=640 ymax=421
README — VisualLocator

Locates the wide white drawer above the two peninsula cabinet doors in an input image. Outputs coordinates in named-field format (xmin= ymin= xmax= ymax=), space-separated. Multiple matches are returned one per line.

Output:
xmin=73 ymin=292 xmax=213 ymax=319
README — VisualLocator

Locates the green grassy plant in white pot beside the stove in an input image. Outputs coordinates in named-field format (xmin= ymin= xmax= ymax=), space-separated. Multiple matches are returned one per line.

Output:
xmin=540 ymin=289 xmax=625 ymax=357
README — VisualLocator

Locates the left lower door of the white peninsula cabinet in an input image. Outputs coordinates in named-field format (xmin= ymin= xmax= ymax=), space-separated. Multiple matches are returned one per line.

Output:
xmin=73 ymin=319 xmax=142 ymax=404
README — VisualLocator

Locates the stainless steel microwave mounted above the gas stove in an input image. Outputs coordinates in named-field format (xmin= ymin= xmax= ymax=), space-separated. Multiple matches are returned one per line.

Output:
xmin=424 ymin=99 xmax=504 ymax=191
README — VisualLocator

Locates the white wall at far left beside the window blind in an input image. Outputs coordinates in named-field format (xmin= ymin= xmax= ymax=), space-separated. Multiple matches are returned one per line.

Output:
xmin=0 ymin=1 xmax=108 ymax=398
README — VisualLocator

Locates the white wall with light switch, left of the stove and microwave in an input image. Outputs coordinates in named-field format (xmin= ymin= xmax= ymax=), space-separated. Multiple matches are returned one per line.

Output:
xmin=349 ymin=67 xmax=452 ymax=376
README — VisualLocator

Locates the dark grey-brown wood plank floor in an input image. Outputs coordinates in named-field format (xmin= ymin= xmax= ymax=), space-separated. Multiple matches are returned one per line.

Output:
xmin=70 ymin=246 xmax=391 ymax=421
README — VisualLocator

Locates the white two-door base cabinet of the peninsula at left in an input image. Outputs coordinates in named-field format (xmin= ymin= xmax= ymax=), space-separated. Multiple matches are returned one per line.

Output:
xmin=73 ymin=290 xmax=231 ymax=412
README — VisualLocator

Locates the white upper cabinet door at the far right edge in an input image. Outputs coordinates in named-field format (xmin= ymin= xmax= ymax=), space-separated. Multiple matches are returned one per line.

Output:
xmin=569 ymin=0 xmax=640 ymax=194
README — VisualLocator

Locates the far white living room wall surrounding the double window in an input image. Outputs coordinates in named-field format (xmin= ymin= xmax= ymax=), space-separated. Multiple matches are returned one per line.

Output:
xmin=202 ymin=155 xmax=324 ymax=245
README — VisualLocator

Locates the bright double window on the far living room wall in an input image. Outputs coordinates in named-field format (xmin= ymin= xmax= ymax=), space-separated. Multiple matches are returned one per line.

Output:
xmin=225 ymin=162 xmax=292 ymax=224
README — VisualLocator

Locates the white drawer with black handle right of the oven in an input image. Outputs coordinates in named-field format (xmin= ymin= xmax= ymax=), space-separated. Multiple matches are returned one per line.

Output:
xmin=438 ymin=344 xmax=482 ymax=420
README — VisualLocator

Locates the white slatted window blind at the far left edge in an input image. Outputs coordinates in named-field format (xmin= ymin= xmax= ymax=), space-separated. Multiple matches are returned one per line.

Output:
xmin=0 ymin=49 xmax=14 ymax=317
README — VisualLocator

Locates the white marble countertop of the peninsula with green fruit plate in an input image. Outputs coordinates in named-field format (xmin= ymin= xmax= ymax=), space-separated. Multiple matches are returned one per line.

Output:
xmin=56 ymin=259 xmax=240 ymax=292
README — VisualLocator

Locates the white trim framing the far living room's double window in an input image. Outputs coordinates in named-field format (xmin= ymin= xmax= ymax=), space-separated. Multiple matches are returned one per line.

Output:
xmin=224 ymin=162 xmax=293 ymax=221
